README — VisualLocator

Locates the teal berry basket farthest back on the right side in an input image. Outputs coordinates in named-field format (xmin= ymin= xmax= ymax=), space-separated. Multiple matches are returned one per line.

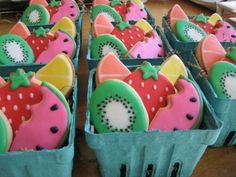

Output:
xmin=162 ymin=16 xmax=233 ymax=52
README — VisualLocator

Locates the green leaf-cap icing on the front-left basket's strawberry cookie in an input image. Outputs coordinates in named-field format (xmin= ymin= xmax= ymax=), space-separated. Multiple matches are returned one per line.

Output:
xmin=10 ymin=69 xmax=33 ymax=90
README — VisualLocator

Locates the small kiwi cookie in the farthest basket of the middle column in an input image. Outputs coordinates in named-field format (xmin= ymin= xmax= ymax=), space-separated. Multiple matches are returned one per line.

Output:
xmin=91 ymin=4 xmax=122 ymax=24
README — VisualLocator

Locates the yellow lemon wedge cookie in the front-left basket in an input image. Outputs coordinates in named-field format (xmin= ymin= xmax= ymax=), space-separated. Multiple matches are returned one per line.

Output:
xmin=35 ymin=54 xmax=75 ymax=96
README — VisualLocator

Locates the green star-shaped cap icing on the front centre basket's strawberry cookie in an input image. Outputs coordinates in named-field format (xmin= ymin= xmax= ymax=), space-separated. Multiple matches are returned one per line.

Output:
xmin=140 ymin=62 xmax=161 ymax=80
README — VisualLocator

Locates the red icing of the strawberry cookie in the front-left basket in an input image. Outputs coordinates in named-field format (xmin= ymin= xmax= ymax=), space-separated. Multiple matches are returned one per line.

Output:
xmin=0 ymin=78 xmax=42 ymax=134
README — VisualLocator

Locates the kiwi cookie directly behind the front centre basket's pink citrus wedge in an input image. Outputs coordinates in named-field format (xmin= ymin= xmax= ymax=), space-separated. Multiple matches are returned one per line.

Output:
xmin=90 ymin=34 xmax=128 ymax=60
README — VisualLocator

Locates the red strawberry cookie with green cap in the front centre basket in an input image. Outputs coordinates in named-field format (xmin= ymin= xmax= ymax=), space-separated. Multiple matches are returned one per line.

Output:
xmin=124 ymin=62 xmax=175 ymax=121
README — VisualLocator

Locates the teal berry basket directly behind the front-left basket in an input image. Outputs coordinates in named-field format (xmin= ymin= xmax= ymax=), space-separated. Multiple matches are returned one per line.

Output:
xmin=0 ymin=11 xmax=83 ymax=77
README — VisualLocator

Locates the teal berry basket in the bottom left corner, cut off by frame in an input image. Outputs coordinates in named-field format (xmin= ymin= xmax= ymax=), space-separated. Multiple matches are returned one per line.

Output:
xmin=0 ymin=70 xmax=78 ymax=177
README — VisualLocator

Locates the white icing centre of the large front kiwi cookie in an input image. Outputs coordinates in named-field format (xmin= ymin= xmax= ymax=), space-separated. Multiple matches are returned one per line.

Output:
xmin=105 ymin=101 xmax=132 ymax=129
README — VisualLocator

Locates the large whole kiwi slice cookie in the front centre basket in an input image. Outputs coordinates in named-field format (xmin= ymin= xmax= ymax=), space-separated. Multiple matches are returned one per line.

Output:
xmin=90 ymin=79 xmax=149 ymax=133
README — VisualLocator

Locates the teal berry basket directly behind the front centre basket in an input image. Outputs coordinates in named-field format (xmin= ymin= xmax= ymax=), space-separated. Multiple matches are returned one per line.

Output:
xmin=86 ymin=27 xmax=172 ymax=70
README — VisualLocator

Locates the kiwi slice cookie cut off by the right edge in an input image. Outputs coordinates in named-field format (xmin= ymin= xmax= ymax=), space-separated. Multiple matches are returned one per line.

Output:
xmin=209 ymin=61 xmax=236 ymax=99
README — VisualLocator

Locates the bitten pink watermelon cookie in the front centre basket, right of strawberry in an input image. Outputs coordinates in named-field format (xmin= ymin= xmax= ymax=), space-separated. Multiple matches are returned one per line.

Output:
xmin=149 ymin=77 xmax=203 ymax=131
